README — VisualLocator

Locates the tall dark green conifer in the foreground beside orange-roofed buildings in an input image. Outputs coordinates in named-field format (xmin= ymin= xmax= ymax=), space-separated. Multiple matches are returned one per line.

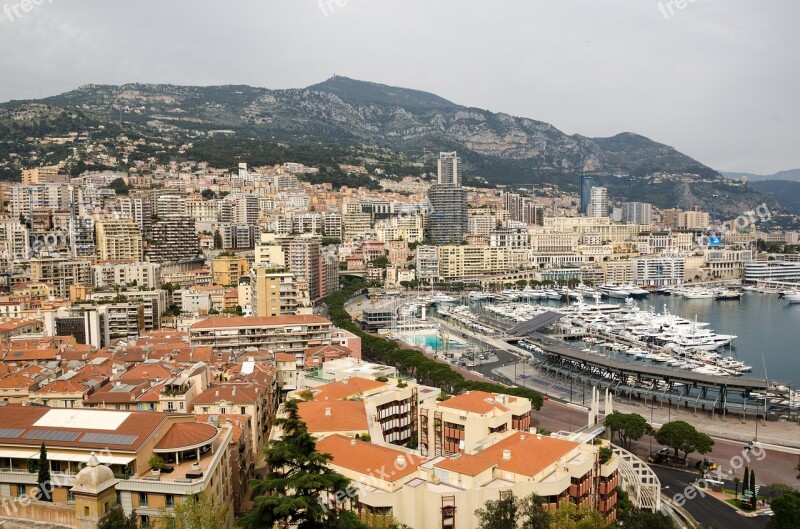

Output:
xmin=240 ymin=399 xmax=365 ymax=529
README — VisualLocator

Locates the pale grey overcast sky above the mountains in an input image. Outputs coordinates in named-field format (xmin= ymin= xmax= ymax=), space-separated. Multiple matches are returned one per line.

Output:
xmin=0 ymin=0 xmax=800 ymax=173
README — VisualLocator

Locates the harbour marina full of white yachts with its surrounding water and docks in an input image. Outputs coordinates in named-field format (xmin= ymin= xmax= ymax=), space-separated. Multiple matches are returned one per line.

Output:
xmin=368 ymin=285 xmax=800 ymax=418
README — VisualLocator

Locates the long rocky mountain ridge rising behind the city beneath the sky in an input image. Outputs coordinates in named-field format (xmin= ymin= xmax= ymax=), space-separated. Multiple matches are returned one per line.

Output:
xmin=0 ymin=76 xmax=776 ymax=212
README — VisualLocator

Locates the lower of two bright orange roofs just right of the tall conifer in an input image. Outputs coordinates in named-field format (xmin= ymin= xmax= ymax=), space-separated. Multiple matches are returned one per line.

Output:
xmin=317 ymin=434 xmax=424 ymax=482
